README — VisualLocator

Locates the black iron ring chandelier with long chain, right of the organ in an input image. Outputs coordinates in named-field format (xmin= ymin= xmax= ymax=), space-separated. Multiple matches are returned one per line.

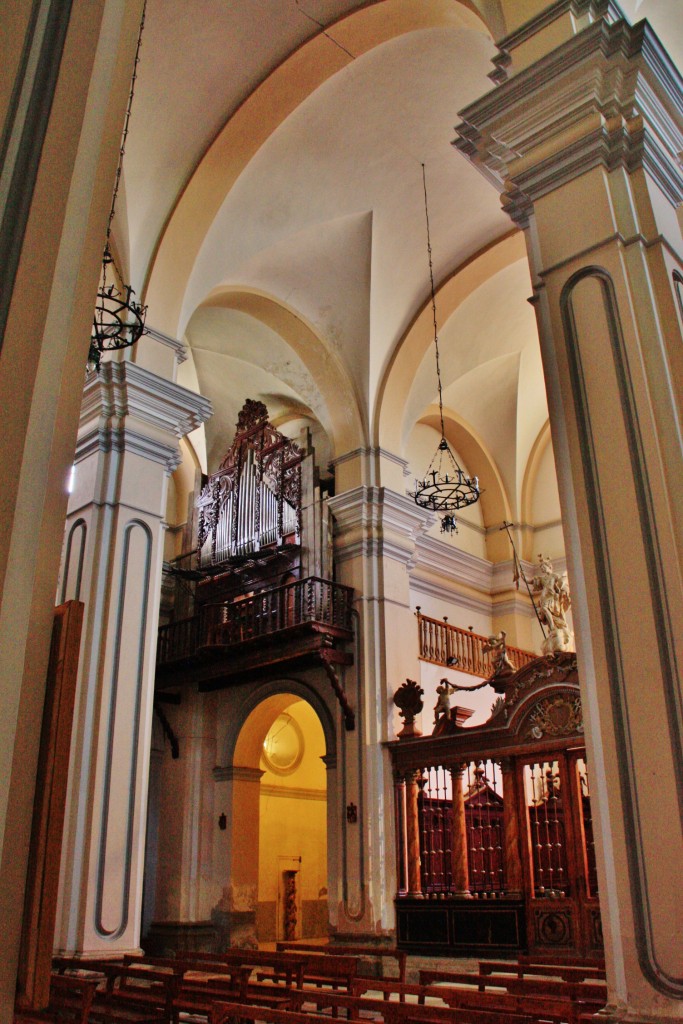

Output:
xmin=412 ymin=164 xmax=479 ymax=534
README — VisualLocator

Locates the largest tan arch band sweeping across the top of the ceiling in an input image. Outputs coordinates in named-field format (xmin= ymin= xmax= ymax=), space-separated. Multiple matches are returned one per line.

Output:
xmin=142 ymin=0 xmax=501 ymax=336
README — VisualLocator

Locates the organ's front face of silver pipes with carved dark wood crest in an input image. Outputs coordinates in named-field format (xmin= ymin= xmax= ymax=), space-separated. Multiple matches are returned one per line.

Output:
xmin=197 ymin=399 xmax=305 ymax=568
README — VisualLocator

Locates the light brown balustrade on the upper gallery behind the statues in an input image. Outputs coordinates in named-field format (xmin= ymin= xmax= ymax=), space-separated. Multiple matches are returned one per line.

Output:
xmin=418 ymin=610 xmax=538 ymax=679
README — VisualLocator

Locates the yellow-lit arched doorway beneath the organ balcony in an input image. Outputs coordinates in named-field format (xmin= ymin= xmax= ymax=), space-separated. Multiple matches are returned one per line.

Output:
xmin=229 ymin=691 xmax=329 ymax=943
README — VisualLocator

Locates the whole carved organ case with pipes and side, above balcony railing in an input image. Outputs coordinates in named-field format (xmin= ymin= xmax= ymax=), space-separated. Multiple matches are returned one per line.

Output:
xmin=196 ymin=399 xmax=332 ymax=599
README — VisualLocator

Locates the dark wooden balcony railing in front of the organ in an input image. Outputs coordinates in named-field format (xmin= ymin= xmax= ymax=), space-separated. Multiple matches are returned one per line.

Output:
xmin=157 ymin=577 xmax=353 ymax=665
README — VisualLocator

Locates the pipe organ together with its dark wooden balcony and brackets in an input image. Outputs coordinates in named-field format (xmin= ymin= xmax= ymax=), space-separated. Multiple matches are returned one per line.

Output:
xmin=157 ymin=400 xmax=353 ymax=728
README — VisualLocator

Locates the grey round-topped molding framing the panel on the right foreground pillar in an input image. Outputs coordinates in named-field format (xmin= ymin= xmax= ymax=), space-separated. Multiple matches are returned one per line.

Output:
xmin=560 ymin=266 xmax=683 ymax=999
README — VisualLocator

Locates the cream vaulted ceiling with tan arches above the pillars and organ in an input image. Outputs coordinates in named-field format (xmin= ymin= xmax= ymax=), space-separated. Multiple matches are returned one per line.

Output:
xmin=115 ymin=0 xmax=683 ymax=528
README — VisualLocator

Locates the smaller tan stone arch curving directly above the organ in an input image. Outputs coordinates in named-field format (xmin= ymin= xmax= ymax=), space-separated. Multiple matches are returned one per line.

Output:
xmin=194 ymin=286 xmax=366 ymax=455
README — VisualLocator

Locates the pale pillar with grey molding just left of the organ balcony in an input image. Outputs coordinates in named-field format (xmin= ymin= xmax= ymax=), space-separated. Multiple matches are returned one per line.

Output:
xmin=55 ymin=361 xmax=210 ymax=955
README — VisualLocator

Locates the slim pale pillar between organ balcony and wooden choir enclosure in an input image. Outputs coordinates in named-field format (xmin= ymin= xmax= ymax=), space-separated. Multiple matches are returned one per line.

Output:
xmin=330 ymin=466 xmax=429 ymax=936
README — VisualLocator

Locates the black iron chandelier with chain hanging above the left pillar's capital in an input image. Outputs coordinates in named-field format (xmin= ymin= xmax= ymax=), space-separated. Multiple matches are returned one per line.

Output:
xmin=88 ymin=0 xmax=147 ymax=370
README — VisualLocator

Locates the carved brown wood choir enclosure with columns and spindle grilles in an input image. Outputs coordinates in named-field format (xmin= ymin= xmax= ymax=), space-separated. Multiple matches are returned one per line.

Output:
xmin=388 ymin=652 xmax=602 ymax=956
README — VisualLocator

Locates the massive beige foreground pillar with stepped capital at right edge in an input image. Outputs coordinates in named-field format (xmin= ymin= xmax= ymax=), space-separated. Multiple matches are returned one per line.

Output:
xmin=457 ymin=4 xmax=683 ymax=1022
